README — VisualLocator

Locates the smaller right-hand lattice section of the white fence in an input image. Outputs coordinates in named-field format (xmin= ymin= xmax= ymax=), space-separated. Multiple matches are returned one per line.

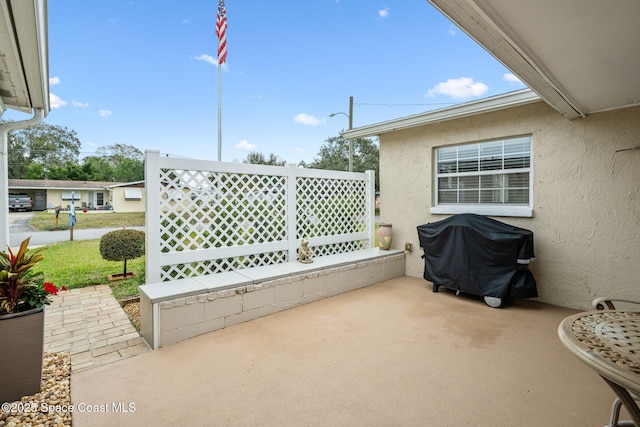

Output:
xmin=296 ymin=177 xmax=369 ymax=256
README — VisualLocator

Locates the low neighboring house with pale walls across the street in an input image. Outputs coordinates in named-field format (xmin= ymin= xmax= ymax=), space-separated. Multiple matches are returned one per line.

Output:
xmin=9 ymin=179 xmax=144 ymax=212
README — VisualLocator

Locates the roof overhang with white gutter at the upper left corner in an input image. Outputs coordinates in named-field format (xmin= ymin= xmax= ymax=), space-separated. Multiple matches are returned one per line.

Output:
xmin=0 ymin=0 xmax=50 ymax=116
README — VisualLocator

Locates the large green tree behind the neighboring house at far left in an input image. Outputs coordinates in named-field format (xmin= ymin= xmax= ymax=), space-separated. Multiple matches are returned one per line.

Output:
xmin=8 ymin=123 xmax=81 ymax=179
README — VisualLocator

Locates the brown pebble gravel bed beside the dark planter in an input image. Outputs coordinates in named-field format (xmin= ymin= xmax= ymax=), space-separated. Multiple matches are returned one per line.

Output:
xmin=0 ymin=353 xmax=72 ymax=427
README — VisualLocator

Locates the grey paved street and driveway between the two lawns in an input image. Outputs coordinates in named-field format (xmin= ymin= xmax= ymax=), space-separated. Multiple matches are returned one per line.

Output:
xmin=9 ymin=212 xmax=144 ymax=248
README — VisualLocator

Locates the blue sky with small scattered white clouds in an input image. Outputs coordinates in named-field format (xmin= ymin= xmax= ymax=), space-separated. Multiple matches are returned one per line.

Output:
xmin=4 ymin=0 xmax=524 ymax=163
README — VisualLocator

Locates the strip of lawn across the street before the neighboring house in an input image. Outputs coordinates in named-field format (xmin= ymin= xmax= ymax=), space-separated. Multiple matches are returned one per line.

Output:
xmin=29 ymin=209 xmax=144 ymax=231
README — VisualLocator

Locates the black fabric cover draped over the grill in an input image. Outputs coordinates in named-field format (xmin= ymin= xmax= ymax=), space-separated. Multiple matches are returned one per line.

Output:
xmin=418 ymin=214 xmax=538 ymax=298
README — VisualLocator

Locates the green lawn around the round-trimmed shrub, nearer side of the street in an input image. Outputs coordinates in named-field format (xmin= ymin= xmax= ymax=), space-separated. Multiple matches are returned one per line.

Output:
xmin=34 ymin=239 xmax=145 ymax=299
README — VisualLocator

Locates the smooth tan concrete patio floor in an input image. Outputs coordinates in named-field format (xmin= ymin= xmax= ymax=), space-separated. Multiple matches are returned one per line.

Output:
xmin=71 ymin=277 xmax=626 ymax=427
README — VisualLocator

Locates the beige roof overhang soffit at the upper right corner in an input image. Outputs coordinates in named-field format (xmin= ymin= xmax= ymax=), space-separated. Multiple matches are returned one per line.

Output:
xmin=428 ymin=0 xmax=640 ymax=119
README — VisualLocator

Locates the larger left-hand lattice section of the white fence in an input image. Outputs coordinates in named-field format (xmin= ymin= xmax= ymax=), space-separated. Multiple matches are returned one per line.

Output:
xmin=160 ymin=169 xmax=287 ymax=280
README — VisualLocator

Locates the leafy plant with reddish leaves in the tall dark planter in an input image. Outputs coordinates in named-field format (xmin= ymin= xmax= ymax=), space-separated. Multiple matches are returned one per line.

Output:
xmin=0 ymin=238 xmax=64 ymax=315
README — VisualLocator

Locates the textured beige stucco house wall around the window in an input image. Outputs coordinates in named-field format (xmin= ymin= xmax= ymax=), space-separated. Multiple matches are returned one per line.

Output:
xmin=380 ymin=102 xmax=640 ymax=309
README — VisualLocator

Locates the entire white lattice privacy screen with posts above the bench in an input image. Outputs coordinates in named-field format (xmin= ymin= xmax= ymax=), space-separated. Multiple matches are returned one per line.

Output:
xmin=145 ymin=151 xmax=375 ymax=283
